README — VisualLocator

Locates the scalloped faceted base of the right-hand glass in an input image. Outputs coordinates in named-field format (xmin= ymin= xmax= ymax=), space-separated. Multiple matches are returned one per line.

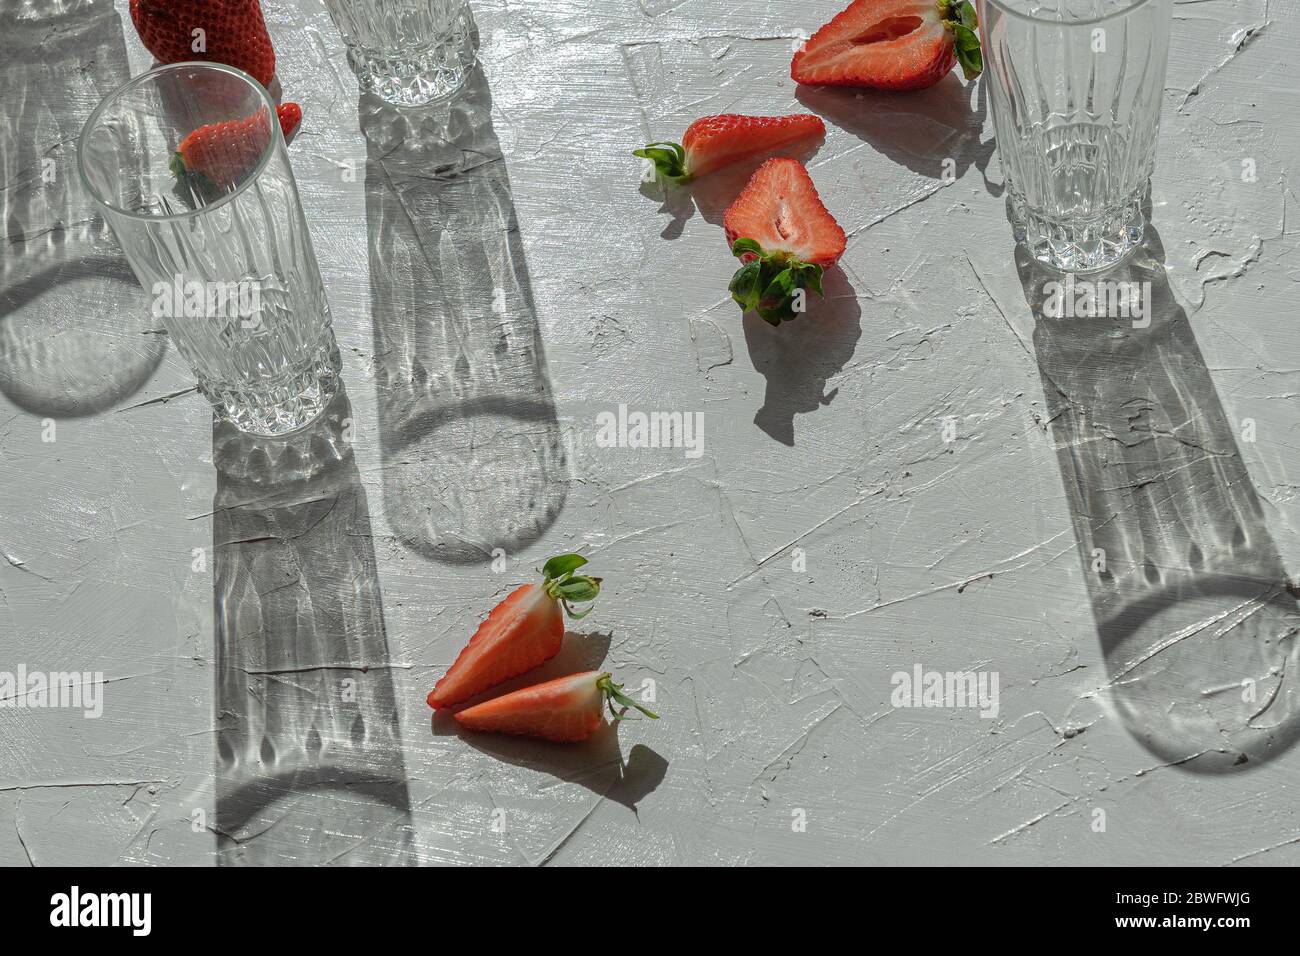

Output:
xmin=1006 ymin=194 xmax=1147 ymax=273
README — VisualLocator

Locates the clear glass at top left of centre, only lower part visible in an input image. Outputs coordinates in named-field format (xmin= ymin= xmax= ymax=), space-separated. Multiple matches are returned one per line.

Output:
xmin=325 ymin=0 xmax=475 ymax=107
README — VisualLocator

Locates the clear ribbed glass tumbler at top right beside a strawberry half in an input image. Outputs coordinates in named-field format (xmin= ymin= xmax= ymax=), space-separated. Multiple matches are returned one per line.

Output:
xmin=979 ymin=0 xmax=1173 ymax=272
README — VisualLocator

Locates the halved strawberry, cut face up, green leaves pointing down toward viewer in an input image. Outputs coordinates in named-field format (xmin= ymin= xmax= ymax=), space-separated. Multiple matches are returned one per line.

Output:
xmin=723 ymin=159 xmax=846 ymax=325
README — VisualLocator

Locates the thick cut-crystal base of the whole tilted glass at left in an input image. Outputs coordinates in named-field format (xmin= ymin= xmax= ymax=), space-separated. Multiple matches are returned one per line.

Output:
xmin=199 ymin=333 xmax=343 ymax=438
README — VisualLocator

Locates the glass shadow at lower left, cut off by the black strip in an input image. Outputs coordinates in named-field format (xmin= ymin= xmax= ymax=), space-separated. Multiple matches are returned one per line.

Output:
xmin=212 ymin=389 xmax=416 ymax=865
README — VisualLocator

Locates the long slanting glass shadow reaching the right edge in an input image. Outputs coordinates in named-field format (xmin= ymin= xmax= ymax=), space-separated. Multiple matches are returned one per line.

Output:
xmin=1015 ymin=222 xmax=1300 ymax=773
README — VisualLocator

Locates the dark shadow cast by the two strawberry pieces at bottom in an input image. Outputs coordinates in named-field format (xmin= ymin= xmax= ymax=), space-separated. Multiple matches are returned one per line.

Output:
xmin=430 ymin=631 xmax=668 ymax=813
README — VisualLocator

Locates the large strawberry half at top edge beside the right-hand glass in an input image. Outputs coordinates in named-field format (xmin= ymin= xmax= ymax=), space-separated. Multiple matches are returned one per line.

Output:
xmin=790 ymin=0 xmax=984 ymax=90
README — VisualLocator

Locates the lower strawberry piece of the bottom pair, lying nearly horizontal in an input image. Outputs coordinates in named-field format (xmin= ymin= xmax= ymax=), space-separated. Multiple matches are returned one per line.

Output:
xmin=456 ymin=671 xmax=659 ymax=741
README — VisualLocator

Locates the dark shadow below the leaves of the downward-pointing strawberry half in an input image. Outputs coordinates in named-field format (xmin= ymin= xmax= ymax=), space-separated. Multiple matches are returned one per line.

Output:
xmin=742 ymin=268 xmax=862 ymax=447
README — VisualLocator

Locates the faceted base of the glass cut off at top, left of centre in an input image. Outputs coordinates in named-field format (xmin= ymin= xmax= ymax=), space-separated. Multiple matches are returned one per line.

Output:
xmin=347 ymin=9 xmax=475 ymax=107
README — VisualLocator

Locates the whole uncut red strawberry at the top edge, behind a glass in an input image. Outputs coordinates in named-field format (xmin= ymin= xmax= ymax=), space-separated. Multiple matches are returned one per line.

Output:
xmin=131 ymin=0 xmax=276 ymax=86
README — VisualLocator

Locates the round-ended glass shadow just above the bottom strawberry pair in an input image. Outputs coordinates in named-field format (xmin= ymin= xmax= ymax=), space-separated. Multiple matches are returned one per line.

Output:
xmin=359 ymin=57 xmax=568 ymax=563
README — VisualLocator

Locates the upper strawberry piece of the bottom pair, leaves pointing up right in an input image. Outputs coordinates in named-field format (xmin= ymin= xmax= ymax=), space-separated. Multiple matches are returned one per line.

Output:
xmin=428 ymin=554 xmax=601 ymax=710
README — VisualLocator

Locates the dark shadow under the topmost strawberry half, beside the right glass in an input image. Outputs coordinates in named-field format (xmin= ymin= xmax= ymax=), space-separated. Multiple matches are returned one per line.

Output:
xmin=794 ymin=73 xmax=1004 ymax=196
